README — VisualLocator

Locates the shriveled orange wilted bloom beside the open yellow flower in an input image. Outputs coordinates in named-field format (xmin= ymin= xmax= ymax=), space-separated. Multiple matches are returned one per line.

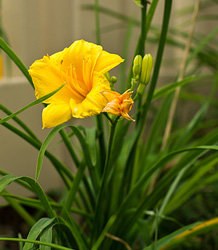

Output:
xmin=101 ymin=89 xmax=135 ymax=121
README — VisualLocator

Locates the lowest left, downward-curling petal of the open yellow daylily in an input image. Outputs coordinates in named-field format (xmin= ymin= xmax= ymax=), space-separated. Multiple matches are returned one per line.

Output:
xmin=42 ymin=103 xmax=72 ymax=128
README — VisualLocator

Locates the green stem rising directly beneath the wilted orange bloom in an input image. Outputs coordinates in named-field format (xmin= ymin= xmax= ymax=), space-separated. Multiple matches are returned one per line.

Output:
xmin=91 ymin=117 xmax=119 ymax=246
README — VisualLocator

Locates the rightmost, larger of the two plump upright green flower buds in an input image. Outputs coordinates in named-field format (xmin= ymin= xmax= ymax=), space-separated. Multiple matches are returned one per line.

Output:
xmin=140 ymin=54 xmax=153 ymax=85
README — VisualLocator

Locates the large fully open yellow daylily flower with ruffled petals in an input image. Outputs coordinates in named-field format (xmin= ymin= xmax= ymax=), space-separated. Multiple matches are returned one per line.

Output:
xmin=29 ymin=40 xmax=123 ymax=128
